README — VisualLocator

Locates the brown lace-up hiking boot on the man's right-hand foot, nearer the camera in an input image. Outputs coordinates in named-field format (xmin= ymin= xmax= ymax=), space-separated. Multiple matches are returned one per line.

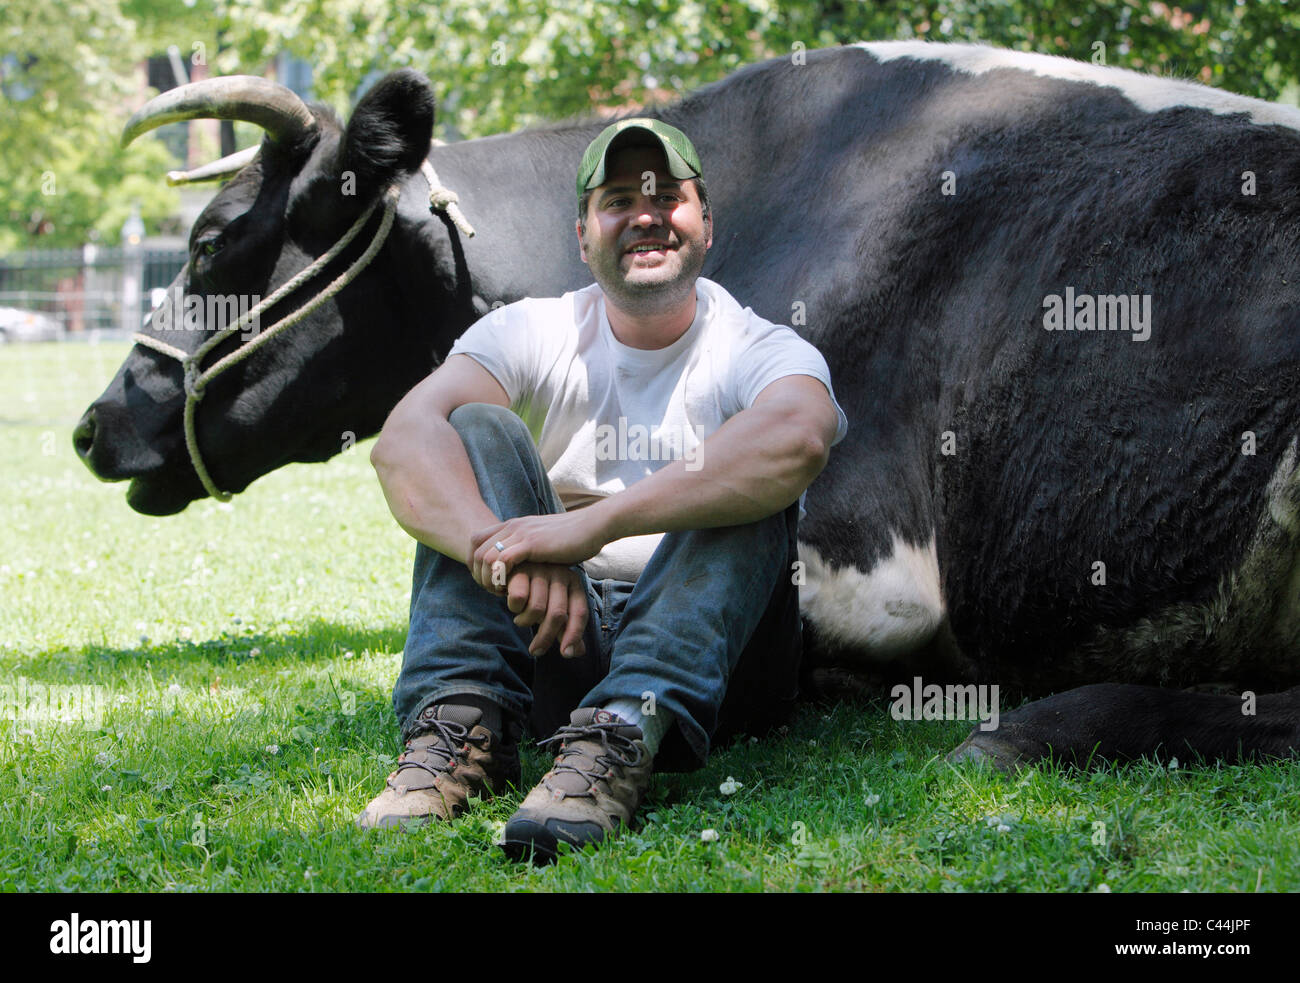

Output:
xmin=502 ymin=707 xmax=654 ymax=863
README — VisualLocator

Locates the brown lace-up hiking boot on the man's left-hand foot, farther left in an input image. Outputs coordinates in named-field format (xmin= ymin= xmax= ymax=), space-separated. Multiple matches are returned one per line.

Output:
xmin=356 ymin=703 xmax=519 ymax=830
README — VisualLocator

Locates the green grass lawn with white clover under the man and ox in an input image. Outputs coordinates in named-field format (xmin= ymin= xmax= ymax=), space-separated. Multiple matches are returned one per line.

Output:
xmin=0 ymin=343 xmax=1300 ymax=891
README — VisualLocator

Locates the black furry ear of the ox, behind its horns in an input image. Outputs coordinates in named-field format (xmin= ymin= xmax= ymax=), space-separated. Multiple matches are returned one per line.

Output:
xmin=338 ymin=69 xmax=434 ymax=194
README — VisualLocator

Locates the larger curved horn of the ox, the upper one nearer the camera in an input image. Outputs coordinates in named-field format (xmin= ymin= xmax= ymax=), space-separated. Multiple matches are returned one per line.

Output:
xmin=122 ymin=75 xmax=316 ymax=147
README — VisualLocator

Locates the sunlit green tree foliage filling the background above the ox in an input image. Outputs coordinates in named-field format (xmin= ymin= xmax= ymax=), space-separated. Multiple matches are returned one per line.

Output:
xmin=0 ymin=0 xmax=1300 ymax=250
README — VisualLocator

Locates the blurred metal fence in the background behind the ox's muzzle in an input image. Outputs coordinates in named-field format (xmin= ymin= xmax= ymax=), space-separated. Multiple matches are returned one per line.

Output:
xmin=0 ymin=246 xmax=186 ymax=338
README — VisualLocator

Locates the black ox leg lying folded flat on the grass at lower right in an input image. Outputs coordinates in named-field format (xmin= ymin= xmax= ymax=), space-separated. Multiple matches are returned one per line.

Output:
xmin=948 ymin=683 xmax=1300 ymax=771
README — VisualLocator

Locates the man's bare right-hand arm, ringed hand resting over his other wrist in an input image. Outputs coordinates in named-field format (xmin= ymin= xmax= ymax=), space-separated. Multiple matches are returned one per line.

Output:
xmin=471 ymin=376 xmax=839 ymax=583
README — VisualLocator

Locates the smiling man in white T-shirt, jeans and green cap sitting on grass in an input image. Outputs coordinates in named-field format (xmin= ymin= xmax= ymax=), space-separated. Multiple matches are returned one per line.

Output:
xmin=359 ymin=118 xmax=848 ymax=859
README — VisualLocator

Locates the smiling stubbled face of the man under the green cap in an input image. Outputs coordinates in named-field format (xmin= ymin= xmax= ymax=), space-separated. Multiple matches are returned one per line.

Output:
xmin=579 ymin=146 xmax=714 ymax=313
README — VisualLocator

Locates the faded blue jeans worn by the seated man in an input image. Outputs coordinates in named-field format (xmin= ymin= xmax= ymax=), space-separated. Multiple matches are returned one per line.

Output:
xmin=393 ymin=403 xmax=802 ymax=771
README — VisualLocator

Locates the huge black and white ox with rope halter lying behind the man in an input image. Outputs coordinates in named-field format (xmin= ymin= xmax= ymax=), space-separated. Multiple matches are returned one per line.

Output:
xmin=75 ymin=42 xmax=1300 ymax=766
